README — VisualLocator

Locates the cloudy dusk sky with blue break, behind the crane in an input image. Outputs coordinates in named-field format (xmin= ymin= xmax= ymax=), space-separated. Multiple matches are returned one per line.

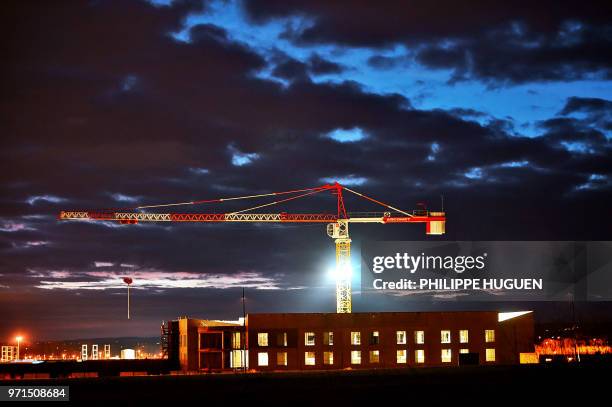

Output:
xmin=0 ymin=0 xmax=612 ymax=341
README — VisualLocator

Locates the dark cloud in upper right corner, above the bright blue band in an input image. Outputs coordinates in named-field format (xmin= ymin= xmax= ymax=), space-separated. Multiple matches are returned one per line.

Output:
xmin=245 ymin=0 xmax=612 ymax=84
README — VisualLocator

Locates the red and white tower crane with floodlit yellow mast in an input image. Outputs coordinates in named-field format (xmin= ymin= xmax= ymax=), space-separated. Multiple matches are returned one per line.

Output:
xmin=58 ymin=182 xmax=446 ymax=313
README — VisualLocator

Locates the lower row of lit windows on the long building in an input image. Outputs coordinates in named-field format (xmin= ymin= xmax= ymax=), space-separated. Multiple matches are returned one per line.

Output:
xmin=257 ymin=348 xmax=495 ymax=366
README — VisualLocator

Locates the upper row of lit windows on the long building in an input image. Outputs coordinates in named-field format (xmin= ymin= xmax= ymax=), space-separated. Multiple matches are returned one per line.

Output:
xmin=257 ymin=329 xmax=495 ymax=346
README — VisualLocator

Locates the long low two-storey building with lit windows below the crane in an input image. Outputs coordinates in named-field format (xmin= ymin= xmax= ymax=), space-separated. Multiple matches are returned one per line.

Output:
xmin=163 ymin=311 xmax=537 ymax=371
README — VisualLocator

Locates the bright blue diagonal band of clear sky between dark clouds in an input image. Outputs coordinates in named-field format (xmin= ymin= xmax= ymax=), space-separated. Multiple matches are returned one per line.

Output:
xmin=164 ymin=0 xmax=612 ymax=137
